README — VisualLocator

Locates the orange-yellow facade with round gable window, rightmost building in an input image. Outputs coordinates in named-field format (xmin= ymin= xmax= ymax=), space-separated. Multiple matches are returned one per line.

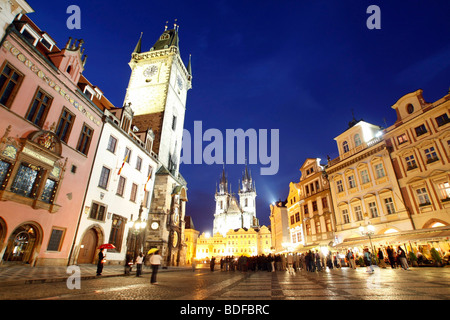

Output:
xmin=385 ymin=90 xmax=450 ymax=229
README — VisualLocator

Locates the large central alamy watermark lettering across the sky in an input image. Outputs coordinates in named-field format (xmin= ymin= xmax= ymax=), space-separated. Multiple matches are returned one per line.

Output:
xmin=181 ymin=121 xmax=280 ymax=175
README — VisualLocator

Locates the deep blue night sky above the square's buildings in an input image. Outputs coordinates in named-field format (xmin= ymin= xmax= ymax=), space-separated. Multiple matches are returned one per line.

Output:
xmin=28 ymin=0 xmax=450 ymax=232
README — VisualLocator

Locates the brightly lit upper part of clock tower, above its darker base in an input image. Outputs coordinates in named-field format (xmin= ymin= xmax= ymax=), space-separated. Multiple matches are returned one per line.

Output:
xmin=124 ymin=24 xmax=192 ymax=175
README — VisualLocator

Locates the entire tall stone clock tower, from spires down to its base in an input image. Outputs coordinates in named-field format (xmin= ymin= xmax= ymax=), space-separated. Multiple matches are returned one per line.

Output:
xmin=124 ymin=24 xmax=192 ymax=266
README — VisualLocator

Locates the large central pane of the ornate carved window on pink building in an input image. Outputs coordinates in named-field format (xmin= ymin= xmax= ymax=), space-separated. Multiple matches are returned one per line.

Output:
xmin=11 ymin=162 xmax=41 ymax=199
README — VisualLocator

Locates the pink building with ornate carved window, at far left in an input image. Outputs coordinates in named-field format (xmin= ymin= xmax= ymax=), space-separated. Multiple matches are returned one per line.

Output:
xmin=0 ymin=16 xmax=103 ymax=266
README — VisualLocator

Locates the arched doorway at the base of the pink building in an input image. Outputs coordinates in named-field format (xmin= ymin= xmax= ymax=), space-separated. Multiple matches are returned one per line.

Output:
xmin=3 ymin=224 xmax=39 ymax=263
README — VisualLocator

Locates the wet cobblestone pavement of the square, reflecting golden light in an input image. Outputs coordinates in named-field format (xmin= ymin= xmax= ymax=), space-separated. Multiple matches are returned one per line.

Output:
xmin=0 ymin=268 xmax=450 ymax=301
